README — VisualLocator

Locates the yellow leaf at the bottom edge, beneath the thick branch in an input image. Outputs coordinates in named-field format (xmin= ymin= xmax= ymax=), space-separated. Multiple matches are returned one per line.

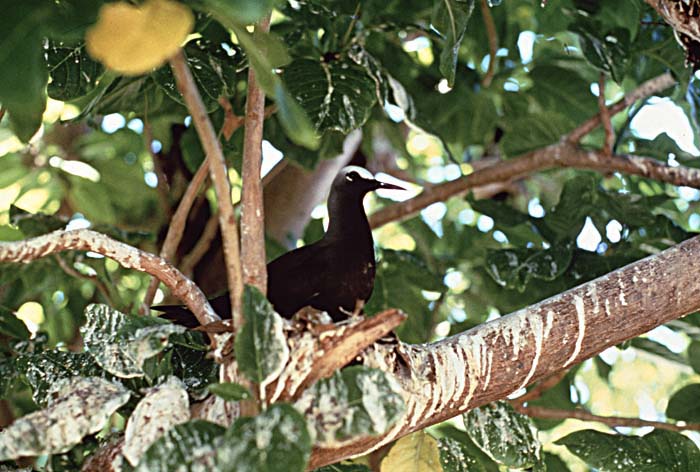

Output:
xmin=381 ymin=431 xmax=442 ymax=472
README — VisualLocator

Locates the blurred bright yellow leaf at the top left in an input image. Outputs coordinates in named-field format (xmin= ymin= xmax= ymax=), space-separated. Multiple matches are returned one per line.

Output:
xmin=85 ymin=0 xmax=194 ymax=75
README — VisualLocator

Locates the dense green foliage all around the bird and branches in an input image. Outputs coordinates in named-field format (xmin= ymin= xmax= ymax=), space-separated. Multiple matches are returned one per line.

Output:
xmin=0 ymin=0 xmax=700 ymax=471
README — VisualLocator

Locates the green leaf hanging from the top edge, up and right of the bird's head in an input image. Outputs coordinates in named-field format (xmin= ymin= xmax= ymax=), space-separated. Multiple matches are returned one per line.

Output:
xmin=430 ymin=0 xmax=476 ymax=87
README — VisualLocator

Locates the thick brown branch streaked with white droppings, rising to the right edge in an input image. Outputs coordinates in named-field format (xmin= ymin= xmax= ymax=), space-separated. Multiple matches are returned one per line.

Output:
xmin=302 ymin=237 xmax=700 ymax=469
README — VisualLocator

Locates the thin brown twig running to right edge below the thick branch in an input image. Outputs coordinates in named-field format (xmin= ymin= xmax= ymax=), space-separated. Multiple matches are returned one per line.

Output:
xmin=513 ymin=404 xmax=700 ymax=432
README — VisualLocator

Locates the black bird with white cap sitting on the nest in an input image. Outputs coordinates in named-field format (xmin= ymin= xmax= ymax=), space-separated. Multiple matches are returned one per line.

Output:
xmin=153 ymin=166 xmax=405 ymax=328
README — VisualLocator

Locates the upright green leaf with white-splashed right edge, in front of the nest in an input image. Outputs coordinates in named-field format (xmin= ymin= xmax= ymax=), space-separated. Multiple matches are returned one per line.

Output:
xmin=234 ymin=286 xmax=289 ymax=386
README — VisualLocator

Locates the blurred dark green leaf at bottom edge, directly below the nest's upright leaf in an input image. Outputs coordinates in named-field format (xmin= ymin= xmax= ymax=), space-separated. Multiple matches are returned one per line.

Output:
xmin=216 ymin=404 xmax=311 ymax=472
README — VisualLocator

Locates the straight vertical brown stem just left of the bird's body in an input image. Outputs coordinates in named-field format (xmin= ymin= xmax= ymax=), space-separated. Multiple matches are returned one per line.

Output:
xmin=242 ymin=15 xmax=270 ymax=296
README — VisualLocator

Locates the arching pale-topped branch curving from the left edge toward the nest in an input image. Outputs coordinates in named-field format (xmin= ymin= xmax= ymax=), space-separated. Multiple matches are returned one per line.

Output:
xmin=0 ymin=229 xmax=220 ymax=324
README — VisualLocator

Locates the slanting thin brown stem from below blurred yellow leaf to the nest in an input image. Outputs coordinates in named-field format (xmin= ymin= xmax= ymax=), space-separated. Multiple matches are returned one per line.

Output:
xmin=170 ymin=50 xmax=243 ymax=326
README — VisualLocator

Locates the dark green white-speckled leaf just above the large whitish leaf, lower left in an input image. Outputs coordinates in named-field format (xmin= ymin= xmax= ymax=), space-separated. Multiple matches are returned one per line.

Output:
xmin=17 ymin=349 xmax=104 ymax=407
